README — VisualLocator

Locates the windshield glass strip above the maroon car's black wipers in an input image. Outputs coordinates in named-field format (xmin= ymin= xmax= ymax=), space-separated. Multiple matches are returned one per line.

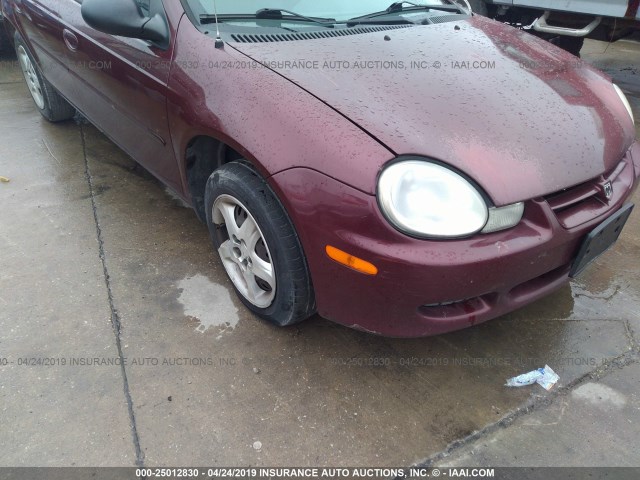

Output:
xmin=191 ymin=0 xmax=451 ymax=21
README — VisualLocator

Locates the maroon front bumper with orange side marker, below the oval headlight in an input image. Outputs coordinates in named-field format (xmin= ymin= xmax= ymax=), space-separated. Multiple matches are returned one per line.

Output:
xmin=271 ymin=143 xmax=640 ymax=337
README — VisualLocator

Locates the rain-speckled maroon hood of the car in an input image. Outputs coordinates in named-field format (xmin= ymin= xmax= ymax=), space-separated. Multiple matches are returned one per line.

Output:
xmin=232 ymin=17 xmax=635 ymax=205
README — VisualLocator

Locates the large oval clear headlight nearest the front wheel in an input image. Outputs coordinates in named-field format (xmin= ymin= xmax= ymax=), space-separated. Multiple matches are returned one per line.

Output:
xmin=378 ymin=160 xmax=489 ymax=238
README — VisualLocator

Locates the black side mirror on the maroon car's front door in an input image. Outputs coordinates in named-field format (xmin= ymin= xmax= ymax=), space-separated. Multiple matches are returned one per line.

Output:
xmin=81 ymin=0 xmax=169 ymax=48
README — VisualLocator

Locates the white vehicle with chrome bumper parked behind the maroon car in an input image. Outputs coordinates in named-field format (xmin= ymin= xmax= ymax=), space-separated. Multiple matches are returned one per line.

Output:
xmin=459 ymin=0 xmax=640 ymax=55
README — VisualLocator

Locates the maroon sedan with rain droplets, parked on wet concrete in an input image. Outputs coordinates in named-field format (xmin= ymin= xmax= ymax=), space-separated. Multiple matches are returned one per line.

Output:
xmin=1 ymin=0 xmax=640 ymax=336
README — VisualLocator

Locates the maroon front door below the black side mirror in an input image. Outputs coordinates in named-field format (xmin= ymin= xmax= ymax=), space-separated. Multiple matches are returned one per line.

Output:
xmin=53 ymin=0 xmax=182 ymax=191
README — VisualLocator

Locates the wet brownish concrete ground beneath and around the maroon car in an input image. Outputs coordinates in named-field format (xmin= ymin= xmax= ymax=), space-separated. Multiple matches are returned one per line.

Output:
xmin=0 ymin=31 xmax=640 ymax=466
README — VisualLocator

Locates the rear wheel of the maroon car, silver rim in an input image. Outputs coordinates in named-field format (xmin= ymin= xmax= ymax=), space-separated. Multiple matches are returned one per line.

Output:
xmin=14 ymin=32 xmax=76 ymax=122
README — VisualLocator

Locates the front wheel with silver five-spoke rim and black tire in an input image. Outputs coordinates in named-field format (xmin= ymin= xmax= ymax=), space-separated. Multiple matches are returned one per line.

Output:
xmin=205 ymin=161 xmax=315 ymax=327
